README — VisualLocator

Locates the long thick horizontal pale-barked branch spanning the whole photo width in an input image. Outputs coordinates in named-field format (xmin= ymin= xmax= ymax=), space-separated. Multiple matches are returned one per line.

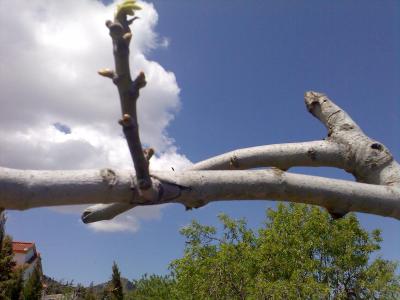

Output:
xmin=0 ymin=169 xmax=400 ymax=219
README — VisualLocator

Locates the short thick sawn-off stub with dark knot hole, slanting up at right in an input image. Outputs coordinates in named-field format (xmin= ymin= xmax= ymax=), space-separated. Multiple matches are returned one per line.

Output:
xmin=304 ymin=92 xmax=400 ymax=185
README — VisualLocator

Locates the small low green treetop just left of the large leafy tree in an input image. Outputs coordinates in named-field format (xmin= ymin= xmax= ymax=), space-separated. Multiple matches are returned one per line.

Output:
xmin=127 ymin=274 xmax=179 ymax=300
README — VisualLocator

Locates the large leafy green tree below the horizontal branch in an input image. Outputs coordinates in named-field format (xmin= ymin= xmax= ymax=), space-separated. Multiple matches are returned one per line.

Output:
xmin=171 ymin=204 xmax=400 ymax=299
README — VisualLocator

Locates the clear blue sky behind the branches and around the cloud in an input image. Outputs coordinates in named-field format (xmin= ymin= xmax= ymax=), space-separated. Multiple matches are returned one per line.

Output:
xmin=0 ymin=0 xmax=400 ymax=284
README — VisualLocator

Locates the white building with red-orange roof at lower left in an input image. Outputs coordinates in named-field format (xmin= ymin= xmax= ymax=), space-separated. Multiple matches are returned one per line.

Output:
xmin=13 ymin=242 xmax=42 ymax=281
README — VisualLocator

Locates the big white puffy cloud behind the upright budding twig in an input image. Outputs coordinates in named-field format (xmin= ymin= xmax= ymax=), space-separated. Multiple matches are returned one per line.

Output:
xmin=0 ymin=0 xmax=190 ymax=231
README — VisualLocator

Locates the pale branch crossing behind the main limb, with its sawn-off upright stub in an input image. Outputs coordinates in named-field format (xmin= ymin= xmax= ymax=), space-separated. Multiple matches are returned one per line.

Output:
xmin=82 ymin=92 xmax=400 ymax=222
